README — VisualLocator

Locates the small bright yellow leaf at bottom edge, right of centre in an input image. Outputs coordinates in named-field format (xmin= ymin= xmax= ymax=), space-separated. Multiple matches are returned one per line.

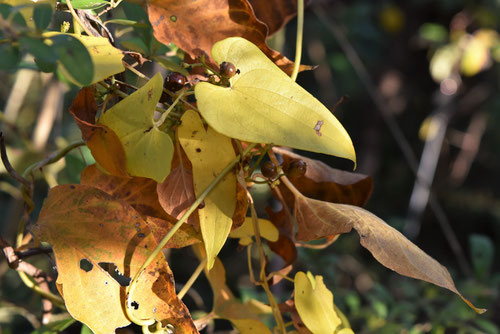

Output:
xmin=294 ymin=271 xmax=341 ymax=334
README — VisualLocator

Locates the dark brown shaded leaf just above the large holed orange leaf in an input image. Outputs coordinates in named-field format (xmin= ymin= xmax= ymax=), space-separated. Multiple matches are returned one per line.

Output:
xmin=80 ymin=165 xmax=200 ymax=248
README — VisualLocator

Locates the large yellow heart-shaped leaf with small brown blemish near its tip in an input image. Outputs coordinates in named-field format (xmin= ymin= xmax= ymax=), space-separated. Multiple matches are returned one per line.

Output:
xmin=195 ymin=37 xmax=356 ymax=162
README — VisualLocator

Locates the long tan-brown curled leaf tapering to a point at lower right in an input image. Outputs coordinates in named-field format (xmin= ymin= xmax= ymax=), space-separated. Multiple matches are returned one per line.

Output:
xmin=292 ymin=189 xmax=486 ymax=313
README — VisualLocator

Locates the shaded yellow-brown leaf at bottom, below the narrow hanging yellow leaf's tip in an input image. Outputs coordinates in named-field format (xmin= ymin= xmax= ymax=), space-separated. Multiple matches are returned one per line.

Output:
xmin=197 ymin=247 xmax=271 ymax=334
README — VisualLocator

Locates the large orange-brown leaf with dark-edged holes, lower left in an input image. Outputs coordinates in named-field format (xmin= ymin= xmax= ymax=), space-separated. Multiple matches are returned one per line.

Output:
xmin=33 ymin=185 xmax=198 ymax=334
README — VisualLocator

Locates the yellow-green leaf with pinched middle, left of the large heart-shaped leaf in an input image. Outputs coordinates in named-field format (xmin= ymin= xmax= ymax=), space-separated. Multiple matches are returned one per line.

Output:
xmin=99 ymin=73 xmax=174 ymax=182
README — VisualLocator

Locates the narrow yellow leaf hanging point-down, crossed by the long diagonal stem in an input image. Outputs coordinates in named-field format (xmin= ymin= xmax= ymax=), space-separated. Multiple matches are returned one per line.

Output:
xmin=178 ymin=110 xmax=236 ymax=268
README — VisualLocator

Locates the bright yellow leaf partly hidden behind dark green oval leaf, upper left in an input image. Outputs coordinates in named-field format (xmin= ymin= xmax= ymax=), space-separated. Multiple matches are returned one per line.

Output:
xmin=43 ymin=32 xmax=125 ymax=85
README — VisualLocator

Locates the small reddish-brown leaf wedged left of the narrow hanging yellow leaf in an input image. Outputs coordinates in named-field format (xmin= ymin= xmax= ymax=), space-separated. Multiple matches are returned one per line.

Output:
xmin=156 ymin=140 xmax=200 ymax=228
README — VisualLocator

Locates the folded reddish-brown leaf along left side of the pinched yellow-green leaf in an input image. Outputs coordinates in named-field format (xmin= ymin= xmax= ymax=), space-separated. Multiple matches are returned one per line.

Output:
xmin=70 ymin=87 xmax=129 ymax=177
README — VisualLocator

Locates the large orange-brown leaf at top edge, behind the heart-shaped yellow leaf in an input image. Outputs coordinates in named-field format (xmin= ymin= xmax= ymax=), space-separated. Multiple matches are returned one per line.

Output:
xmin=148 ymin=0 xmax=302 ymax=74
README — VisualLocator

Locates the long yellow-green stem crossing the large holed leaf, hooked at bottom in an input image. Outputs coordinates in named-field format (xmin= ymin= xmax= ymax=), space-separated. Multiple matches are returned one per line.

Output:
xmin=125 ymin=143 xmax=258 ymax=326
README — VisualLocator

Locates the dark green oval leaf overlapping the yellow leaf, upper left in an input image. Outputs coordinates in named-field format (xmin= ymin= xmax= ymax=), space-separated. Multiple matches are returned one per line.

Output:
xmin=50 ymin=34 xmax=94 ymax=86
